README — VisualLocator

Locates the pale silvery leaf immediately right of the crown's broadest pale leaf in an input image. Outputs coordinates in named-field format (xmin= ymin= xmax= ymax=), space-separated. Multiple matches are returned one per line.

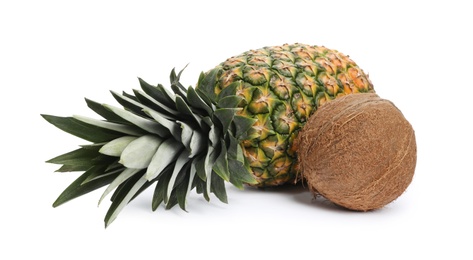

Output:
xmin=145 ymin=139 xmax=183 ymax=180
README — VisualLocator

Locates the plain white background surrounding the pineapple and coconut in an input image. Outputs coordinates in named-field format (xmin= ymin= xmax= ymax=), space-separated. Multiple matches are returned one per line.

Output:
xmin=0 ymin=0 xmax=473 ymax=260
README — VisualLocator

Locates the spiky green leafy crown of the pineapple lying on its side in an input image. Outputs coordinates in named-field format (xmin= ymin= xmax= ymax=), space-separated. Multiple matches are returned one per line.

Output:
xmin=42 ymin=67 xmax=256 ymax=227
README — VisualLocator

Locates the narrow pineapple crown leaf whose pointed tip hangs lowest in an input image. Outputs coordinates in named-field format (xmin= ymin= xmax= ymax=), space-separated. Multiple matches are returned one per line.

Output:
xmin=104 ymin=175 xmax=147 ymax=227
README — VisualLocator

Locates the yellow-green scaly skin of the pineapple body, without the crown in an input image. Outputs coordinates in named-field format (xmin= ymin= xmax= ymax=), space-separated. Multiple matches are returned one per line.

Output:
xmin=206 ymin=43 xmax=374 ymax=187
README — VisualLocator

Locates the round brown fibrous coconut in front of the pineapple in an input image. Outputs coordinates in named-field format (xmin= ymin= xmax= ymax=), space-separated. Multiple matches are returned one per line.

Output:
xmin=298 ymin=93 xmax=417 ymax=211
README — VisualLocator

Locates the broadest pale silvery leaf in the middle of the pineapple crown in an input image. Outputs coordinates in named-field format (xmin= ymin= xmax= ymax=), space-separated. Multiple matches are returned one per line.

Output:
xmin=120 ymin=135 xmax=163 ymax=169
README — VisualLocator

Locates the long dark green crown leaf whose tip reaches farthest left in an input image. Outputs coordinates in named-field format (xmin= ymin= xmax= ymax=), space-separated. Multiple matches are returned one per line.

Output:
xmin=41 ymin=115 xmax=123 ymax=143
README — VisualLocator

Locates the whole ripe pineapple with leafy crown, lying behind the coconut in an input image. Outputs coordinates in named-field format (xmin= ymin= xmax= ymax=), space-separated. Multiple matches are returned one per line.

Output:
xmin=42 ymin=44 xmax=374 ymax=226
